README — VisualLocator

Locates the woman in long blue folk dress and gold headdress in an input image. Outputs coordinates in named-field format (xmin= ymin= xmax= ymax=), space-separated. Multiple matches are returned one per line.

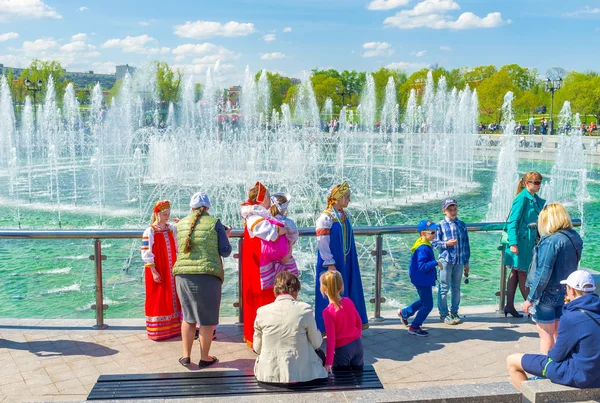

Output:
xmin=315 ymin=181 xmax=369 ymax=332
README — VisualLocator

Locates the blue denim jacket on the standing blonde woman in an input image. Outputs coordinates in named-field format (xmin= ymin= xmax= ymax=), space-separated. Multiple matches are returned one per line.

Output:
xmin=519 ymin=229 xmax=583 ymax=307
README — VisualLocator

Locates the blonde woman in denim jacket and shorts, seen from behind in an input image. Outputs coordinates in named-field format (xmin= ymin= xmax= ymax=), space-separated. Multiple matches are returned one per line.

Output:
xmin=522 ymin=203 xmax=583 ymax=354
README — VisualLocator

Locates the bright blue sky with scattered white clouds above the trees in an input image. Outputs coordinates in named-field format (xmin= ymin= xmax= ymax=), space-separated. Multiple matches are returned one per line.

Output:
xmin=0 ymin=0 xmax=600 ymax=85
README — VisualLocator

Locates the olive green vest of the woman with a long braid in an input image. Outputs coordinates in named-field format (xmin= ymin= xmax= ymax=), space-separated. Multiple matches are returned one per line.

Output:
xmin=173 ymin=213 xmax=223 ymax=282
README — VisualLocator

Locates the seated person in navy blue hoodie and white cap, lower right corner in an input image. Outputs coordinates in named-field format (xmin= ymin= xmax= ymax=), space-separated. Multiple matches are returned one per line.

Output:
xmin=506 ymin=270 xmax=600 ymax=388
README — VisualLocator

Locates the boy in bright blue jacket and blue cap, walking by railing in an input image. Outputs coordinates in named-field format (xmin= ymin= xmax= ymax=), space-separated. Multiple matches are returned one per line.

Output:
xmin=398 ymin=220 xmax=439 ymax=337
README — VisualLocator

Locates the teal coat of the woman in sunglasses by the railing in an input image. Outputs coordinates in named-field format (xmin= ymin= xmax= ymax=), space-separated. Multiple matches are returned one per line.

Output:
xmin=504 ymin=189 xmax=546 ymax=271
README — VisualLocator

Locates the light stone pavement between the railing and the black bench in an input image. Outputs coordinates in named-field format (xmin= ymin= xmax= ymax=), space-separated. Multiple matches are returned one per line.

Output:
xmin=0 ymin=306 xmax=539 ymax=403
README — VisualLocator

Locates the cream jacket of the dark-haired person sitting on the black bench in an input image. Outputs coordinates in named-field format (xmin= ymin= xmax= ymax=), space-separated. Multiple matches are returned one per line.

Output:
xmin=253 ymin=294 xmax=327 ymax=383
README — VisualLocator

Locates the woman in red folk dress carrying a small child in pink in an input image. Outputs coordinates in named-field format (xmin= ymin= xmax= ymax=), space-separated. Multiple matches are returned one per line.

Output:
xmin=241 ymin=182 xmax=287 ymax=347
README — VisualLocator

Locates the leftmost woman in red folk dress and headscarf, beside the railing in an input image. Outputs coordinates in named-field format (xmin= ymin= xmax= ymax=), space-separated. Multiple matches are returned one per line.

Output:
xmin=142 ymin=200 xmax=181 ymax=340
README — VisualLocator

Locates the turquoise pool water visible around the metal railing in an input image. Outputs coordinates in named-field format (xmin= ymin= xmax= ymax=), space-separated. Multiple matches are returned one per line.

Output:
xmin=0 ymin=162 xmax=600 ymax=320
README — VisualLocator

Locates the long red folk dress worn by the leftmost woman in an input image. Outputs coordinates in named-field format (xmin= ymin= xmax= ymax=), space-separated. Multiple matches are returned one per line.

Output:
xmin=144 ymin=231 xmax=181 ymax=340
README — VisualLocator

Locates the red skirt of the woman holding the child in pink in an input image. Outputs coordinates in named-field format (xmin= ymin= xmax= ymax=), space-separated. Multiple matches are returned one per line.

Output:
xmin=242 ymin=226 xmax=275 ymax=347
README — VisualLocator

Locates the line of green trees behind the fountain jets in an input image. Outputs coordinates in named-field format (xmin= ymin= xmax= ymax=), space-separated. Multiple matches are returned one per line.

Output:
xmin=7 ymin=60 xmax=600 ymax=123
